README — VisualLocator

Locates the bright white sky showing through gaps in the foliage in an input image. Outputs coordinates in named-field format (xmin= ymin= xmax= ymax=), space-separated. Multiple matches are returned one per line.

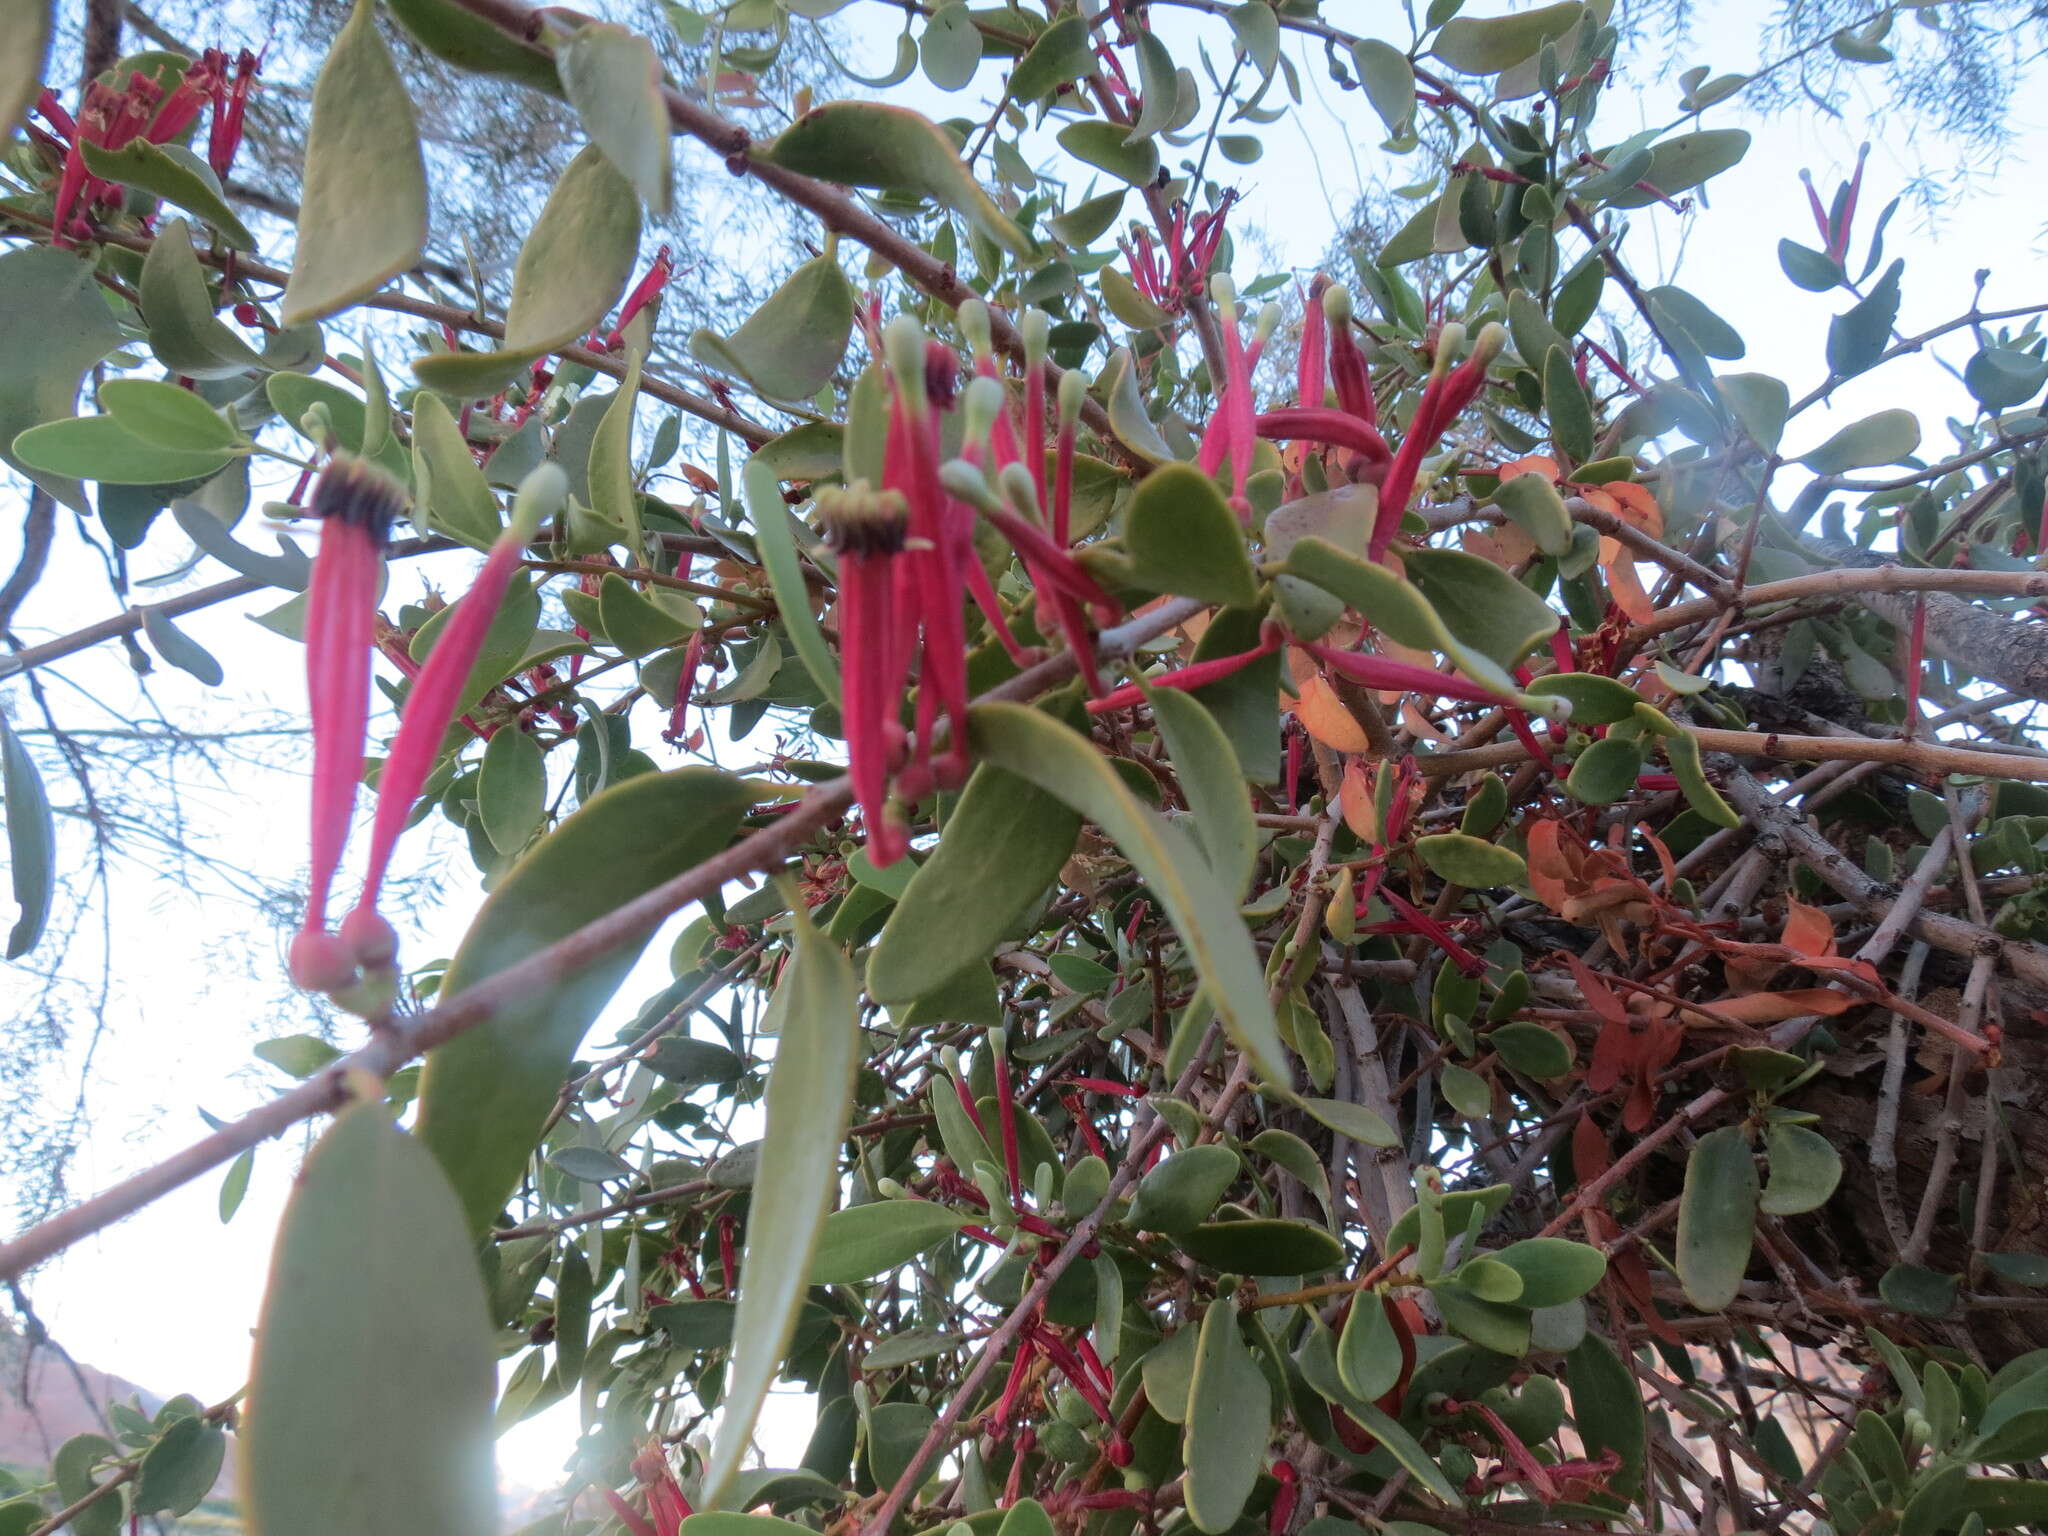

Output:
xmin=0 ymin=0 xmax=2048 ymax=1515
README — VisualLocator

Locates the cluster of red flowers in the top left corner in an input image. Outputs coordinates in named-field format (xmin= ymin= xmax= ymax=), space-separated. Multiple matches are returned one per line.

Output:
xmin=35 ymin=47 xmax=262 ymax=246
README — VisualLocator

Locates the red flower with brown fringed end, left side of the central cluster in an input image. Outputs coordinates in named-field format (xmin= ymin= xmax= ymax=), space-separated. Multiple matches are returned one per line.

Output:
xmin=817 ymin=483 xmax=909 ymax=868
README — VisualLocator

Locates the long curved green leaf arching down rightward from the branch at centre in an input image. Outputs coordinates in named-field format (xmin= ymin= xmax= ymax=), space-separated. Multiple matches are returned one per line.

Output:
xmin=969 ymin=705 xmax=1290 ymax=1085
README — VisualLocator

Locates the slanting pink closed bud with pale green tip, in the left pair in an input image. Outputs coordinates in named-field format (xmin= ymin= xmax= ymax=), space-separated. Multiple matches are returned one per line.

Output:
xmin=342 ymin=463 xmax=567 ymax=973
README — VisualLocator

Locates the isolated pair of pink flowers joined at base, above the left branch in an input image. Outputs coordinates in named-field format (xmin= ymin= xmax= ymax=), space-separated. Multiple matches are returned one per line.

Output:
xmin=291 ymin=455 xmax=567 ymax=1012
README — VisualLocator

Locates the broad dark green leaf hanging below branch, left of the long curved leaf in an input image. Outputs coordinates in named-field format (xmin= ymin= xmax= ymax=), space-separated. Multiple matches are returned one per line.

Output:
xmin=866 ymin=764 xmax=1081 ymax=1011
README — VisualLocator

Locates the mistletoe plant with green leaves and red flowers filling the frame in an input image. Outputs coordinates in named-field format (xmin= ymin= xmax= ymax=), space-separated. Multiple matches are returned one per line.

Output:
xmin=0 ymin=0 xmax=2048 ymax=1536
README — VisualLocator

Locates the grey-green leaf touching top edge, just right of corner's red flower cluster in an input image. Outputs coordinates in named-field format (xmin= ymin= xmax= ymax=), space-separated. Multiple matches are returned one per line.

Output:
xmin=279 ymin=0 xmax=426 ymax=326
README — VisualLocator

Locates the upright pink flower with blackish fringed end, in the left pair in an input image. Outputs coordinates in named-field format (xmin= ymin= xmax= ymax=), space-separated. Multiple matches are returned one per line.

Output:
xmin=291 ymin=457 xmax=403 ymax=991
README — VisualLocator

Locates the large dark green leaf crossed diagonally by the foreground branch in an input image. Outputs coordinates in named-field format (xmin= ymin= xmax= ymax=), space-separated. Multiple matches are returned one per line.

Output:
xmin=420 ymin=768 xmax=752 ymax=1233
